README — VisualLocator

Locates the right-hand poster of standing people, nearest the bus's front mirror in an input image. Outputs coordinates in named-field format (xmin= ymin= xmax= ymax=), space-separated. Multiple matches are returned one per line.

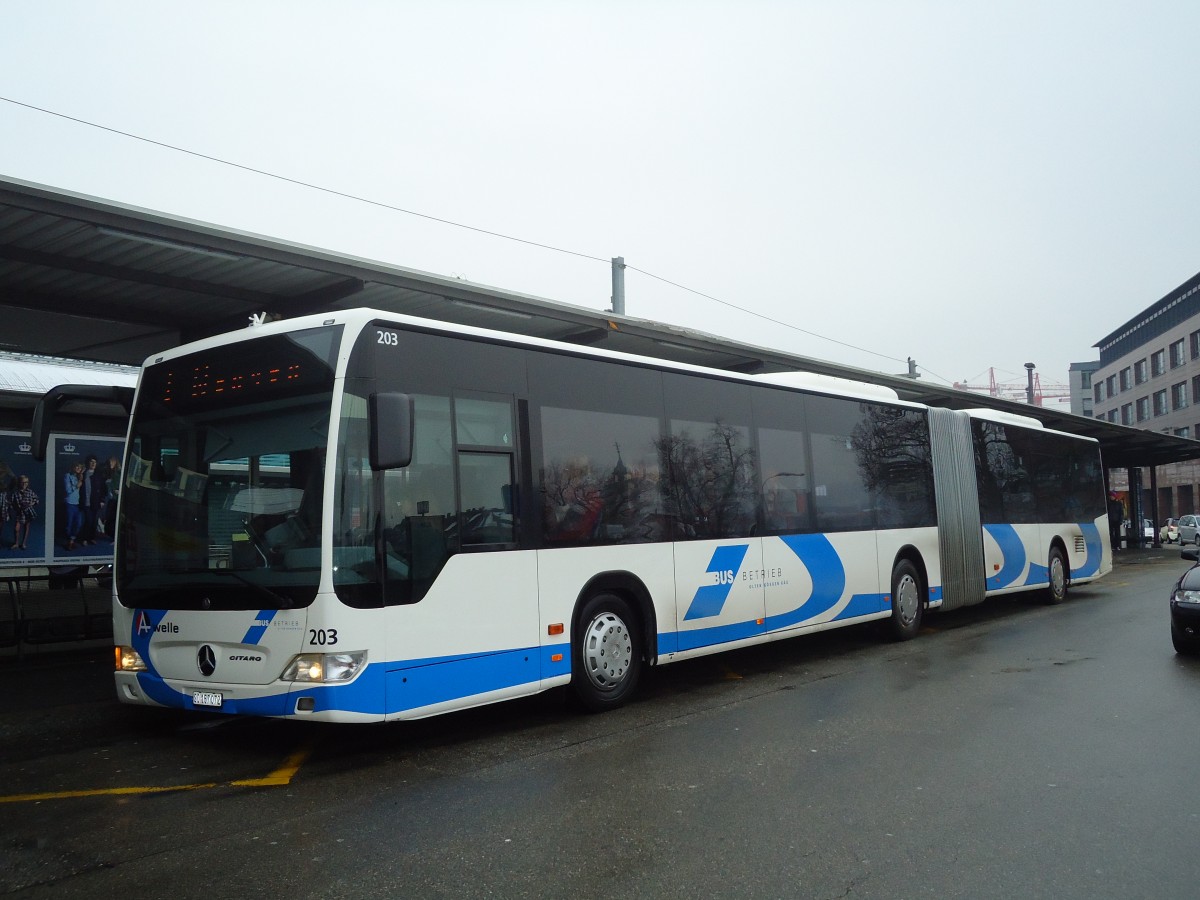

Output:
xmin=46 ymin=434 xmax=125 ymax=565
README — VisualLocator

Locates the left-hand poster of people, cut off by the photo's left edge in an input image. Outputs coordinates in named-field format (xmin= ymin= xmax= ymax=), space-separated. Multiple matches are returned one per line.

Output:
xmin=0 ymin=431 xmax=48 ymax=565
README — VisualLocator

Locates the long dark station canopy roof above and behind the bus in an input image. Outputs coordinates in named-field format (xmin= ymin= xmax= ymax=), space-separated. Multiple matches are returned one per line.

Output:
xmin=0 ymin=178 xmax=1200 ymax=468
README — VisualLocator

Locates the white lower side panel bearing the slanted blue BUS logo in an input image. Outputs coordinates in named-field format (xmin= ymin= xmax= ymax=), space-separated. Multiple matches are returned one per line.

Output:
xmin=674 ymin=538 xmax=766 ymax=650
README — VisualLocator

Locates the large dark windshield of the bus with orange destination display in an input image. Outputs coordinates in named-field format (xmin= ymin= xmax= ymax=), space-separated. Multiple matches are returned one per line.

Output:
xmin=115 ymin=326 xmax=341 ymax=610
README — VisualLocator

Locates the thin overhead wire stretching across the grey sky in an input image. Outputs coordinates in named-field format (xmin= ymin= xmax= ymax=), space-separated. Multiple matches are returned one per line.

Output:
xmin=0 ymin=96 xmax=921 ymax=383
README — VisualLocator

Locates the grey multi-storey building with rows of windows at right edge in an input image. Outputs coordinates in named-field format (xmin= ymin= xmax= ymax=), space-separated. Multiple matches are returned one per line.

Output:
xmin=1094 ymin=274 xmax=1200 ymax=518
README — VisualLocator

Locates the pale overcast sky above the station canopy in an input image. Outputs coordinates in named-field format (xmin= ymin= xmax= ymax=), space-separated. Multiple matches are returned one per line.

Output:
xmin=0 ymin=0 xmax=1200 ymax=393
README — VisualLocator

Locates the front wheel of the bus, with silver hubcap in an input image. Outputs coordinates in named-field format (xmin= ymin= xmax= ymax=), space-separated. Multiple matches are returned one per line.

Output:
xmin=571 ymin=594 xmax=642 ymax=713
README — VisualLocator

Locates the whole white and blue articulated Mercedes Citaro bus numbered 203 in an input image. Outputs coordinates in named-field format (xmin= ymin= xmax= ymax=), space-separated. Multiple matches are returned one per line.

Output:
xmin=38 ymin=310 xmax=1112 ymax=722
